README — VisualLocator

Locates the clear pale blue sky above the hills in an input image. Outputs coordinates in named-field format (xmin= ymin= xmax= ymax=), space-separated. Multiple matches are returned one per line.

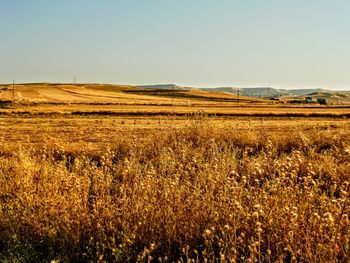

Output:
xmin=0 ymin=0 xmax=350 ymax=89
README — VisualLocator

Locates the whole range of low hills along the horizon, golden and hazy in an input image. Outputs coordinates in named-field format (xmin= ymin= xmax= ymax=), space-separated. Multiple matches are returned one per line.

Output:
xmin=4 ymin=83 xmax=350 ymax=104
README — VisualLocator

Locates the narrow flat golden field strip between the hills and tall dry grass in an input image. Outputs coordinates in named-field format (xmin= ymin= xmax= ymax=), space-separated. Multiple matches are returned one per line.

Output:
xmin=0 ymin=99 xmax=350 ymax=118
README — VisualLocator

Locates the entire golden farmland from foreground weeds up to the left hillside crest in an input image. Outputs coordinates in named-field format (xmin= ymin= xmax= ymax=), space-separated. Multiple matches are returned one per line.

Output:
xmin=0 ymin=84 xmax=350 ymax=262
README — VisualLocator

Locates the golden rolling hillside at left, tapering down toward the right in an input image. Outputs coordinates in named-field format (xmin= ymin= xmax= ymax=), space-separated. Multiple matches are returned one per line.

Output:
xmin=0 ymin=83 xmax=263 ymax=104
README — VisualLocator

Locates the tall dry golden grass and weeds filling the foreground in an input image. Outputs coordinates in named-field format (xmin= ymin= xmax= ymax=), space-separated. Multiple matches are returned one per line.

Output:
xmin=0 ymin=117 xmax=350 ymax=262
